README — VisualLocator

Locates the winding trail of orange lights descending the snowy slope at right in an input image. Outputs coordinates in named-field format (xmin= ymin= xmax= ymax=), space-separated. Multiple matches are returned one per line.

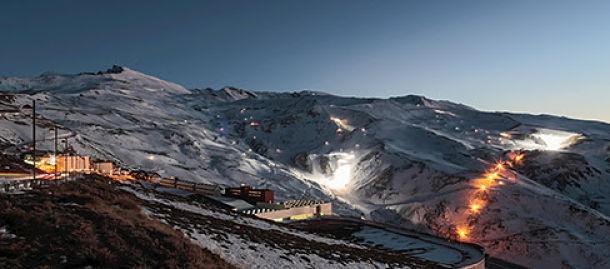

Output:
xmin=455 ymin=152 xmax=525 ymax=241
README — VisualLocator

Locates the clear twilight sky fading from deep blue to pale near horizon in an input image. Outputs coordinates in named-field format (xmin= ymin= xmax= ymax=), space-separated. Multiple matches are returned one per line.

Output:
xmin=0 ymin=0 xmax=610 ymax=122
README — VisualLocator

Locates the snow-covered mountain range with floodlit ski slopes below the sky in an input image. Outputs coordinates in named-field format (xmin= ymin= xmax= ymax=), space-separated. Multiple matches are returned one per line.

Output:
xmin=0 ymin=66 xmax=610 ymax=268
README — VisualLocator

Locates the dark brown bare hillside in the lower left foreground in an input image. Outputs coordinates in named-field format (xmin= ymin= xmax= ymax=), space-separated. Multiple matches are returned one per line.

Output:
xmin=0 ymin=176 xmax=234 ymax=268
